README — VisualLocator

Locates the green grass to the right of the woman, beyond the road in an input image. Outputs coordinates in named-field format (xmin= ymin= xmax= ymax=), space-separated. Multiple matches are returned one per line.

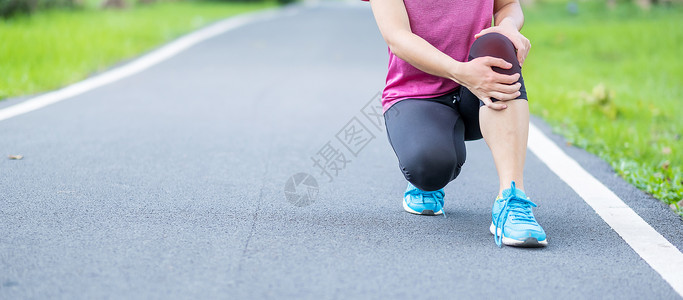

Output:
xmin=523 ymin=1 xmax=683 ymax=216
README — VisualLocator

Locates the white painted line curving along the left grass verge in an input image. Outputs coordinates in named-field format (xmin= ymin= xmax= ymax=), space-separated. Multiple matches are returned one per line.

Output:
xmin=0 ymin=8 xmax=296 ymax=121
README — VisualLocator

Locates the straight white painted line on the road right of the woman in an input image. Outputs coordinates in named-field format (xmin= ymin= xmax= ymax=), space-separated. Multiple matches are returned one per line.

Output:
xmin=529 ymin=124 xmax=683 ymax=297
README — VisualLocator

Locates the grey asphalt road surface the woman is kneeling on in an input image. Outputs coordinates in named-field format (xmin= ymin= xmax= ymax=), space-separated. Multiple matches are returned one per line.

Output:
xmin=0 ymin=4 xmax=683 ymax=299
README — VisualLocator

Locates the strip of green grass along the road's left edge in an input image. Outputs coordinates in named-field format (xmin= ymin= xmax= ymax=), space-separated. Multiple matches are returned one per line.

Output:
xmin=0 ymin=1 xmax=276 ymax=99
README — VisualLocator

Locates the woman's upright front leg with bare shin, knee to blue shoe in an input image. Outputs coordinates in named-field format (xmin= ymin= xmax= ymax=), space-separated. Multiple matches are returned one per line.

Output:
xmin=461 ymin=33 xmax=548 ymax=247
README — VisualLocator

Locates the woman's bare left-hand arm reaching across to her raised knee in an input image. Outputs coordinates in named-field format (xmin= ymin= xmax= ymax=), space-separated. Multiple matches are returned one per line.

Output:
xmin=370 ymin=0 xmax=520 ymax=110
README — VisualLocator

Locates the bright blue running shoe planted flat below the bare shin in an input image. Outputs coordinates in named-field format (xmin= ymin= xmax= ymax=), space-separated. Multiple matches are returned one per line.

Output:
xmin=489 ymin=181 xmax=548 ymax=247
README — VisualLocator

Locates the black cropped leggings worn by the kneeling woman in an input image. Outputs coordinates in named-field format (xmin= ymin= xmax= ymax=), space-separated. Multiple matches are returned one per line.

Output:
xmin=384 ymin=33 xmax=527 ymax=191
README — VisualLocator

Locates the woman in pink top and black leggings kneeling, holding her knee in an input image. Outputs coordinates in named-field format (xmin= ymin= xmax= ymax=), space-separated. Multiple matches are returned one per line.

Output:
xmin=370 ymin=0 xmax=547 ymax=247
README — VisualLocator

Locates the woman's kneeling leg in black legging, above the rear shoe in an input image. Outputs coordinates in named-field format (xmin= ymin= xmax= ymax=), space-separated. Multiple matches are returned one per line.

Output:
xmin=384 ymin=96 xmax=465 ymax=191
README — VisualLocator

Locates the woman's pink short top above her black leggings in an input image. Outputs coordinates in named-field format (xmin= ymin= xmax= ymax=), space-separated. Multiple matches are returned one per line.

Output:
xmin=366 ymin=0 xmax=493 ymax=111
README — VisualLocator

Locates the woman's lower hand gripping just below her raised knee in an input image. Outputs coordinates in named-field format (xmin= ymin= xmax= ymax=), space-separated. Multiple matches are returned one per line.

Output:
xmin=453 ymin=56 xmax=522 ymax=110
